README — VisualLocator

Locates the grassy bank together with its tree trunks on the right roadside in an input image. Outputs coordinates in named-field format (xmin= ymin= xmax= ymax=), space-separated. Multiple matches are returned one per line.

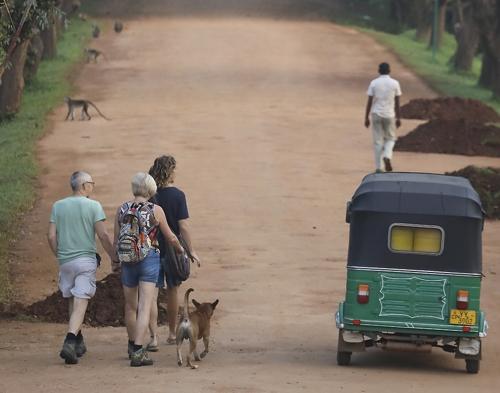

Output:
xmin=334 ymin=0 xmax=500 ymax=112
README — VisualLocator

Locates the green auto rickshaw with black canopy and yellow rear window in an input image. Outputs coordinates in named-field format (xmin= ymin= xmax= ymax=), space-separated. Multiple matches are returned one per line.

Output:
xmin=336 ymin=172 xmax=488 ymax=373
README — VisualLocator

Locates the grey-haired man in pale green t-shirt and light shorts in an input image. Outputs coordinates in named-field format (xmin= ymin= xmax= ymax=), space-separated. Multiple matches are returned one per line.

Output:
xmin=48 ymin=171 xmax=117 ymax=364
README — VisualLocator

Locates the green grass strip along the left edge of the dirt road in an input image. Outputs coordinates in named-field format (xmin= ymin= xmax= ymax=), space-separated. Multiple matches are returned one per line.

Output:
xmin=0 ymin=20 xmax=90 ymax=302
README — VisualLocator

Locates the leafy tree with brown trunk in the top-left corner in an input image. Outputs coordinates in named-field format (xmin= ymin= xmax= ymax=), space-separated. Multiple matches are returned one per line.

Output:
xmin=0 ymin=0 xmax=57 ymax=118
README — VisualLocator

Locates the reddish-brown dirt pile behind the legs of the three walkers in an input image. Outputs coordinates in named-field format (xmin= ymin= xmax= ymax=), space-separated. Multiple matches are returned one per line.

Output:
xmin=0 ymin=274 xmax=171 ymax=326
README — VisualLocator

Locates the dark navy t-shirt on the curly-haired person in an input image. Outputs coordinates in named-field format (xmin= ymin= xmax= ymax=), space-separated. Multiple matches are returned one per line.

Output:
xmin=153 ymin=187 xmax=189 ymax=256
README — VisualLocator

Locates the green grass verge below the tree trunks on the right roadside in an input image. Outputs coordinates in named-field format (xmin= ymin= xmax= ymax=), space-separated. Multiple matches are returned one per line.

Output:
xmin=361 ymin=29 xmax=500 ymax=112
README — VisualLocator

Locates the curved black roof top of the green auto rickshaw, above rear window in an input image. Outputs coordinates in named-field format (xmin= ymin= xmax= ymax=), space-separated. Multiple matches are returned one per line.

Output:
xmin=350 ymin=172 xmax=483 ymax=219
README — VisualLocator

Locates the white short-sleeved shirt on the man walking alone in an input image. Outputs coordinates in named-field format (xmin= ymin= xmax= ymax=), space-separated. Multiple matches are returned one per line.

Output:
xmin=367 ymin=75 xmax=401 ymax=118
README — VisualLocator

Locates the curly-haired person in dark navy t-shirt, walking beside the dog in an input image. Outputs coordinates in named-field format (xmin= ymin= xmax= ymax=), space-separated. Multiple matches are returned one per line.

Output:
xmin=148 ymin=155 xmax=200 ymax=351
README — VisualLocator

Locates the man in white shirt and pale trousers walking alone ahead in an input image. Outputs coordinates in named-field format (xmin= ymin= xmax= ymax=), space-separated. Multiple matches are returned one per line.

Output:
xmin=365 ymin=63 xmax=401 ymax=172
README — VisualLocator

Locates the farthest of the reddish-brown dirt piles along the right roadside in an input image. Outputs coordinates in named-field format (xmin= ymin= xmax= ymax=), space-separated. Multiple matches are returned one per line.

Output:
xmin=401 ymin=97 xmax=500 ymax=124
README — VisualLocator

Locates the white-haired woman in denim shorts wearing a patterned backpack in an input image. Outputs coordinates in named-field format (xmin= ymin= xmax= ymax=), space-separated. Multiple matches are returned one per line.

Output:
xmin=114 ymin=172 xmax=184 ymax=367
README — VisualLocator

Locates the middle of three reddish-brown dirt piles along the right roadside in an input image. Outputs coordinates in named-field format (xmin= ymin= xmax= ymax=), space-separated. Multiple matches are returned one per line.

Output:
xmin=396 ymin=120 xmax=500 ymax=157
